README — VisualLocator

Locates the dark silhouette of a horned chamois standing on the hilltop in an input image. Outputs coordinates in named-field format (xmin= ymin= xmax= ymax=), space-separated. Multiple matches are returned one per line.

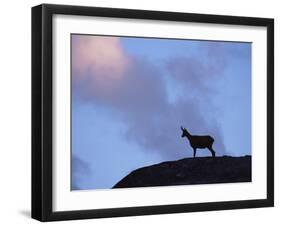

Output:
xmin=181 ymin=126 xmax=216 ymax=158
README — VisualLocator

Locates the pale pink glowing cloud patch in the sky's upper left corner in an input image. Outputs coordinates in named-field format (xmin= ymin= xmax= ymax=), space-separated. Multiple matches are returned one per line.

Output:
xmin=72 ymin=35 xmax=129 ymax=81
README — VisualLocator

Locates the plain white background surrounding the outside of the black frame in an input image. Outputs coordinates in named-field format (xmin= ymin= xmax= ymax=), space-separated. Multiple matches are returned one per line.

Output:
xmin=0 ymin=0 xmax=276 ymax=226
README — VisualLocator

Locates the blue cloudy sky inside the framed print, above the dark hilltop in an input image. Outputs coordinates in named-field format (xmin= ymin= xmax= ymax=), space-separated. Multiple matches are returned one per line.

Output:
xmin=71 ymin=34 xmax=251 ymax=190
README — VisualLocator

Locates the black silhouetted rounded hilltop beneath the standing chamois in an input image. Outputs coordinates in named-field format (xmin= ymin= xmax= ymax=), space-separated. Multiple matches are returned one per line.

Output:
xmin=113 ymin=156 xmax=251 ymax=188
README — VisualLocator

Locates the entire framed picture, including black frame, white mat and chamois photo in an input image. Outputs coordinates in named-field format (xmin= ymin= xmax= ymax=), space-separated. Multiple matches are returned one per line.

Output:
xmin=31 ymin=4 xmax=274 ymax=221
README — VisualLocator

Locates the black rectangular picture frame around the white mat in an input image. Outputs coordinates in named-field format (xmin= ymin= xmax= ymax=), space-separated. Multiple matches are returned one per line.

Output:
xmin=32 ymin=4 xmax=274 ymax=221
